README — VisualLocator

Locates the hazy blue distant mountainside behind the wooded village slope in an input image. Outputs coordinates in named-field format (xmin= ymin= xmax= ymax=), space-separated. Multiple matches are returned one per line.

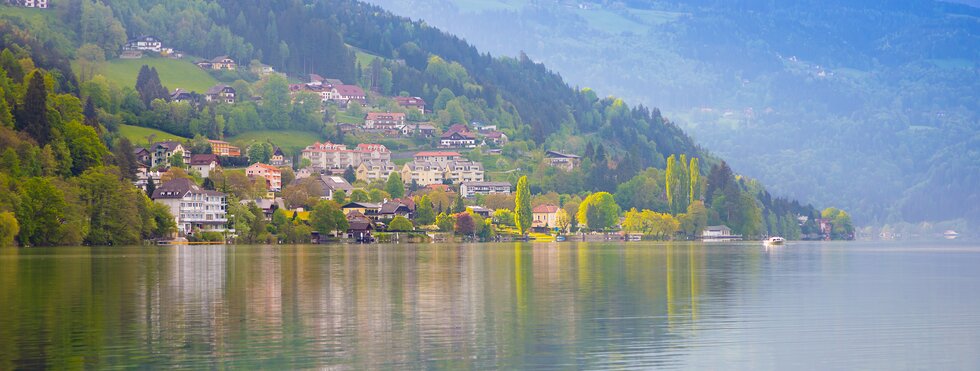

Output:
xmin=372 ymin=0 xmax=980 ymax=224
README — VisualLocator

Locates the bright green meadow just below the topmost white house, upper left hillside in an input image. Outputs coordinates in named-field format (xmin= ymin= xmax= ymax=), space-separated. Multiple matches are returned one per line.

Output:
xmin=96 ymin=57 xmax=218 ymax=93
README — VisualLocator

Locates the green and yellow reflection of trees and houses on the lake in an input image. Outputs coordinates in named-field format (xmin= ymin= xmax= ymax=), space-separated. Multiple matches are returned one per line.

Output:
xmin=0 ymin=243 xmax=726 ymax=369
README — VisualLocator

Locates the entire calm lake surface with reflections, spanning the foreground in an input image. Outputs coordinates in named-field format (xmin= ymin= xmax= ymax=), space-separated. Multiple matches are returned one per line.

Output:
xmin=0 ymin=242 xmax=980 ymax=370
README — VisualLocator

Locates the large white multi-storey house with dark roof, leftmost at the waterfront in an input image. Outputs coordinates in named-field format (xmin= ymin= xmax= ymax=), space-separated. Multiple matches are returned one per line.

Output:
xmin=151 ymin=178 xmax=228 ymax=235
